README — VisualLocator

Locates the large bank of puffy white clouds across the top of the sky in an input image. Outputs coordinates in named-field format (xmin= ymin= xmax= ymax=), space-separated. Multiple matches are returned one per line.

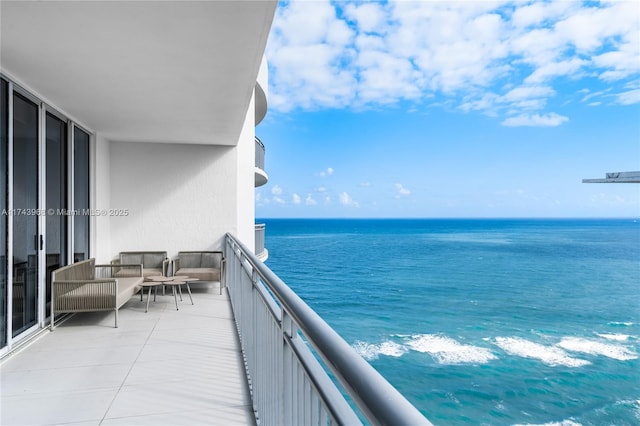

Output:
xmin=267 ymin=0 xmax=640 ymax=120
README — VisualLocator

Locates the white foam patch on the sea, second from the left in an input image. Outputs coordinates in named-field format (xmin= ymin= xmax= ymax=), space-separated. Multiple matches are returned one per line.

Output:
xmin=407 ymin=334 xmax=497 ymax=364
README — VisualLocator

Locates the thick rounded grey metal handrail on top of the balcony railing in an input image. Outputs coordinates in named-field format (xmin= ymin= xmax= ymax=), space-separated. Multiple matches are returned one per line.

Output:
xmin=227 ymin=233 xmax=431 ymax=425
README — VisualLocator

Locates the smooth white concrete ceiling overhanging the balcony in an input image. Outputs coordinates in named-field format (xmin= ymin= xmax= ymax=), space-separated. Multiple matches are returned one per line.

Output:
xmin=0 ymin=0 xmax=277 ymax=145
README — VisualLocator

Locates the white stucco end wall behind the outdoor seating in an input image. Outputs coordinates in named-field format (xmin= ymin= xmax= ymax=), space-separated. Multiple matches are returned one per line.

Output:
xmin=95 ymin=101 xmax=255 ymax=262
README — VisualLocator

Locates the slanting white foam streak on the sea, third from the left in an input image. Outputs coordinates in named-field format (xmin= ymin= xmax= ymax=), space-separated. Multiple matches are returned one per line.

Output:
xmin=495 ymin=337 xmax=590 ymax=367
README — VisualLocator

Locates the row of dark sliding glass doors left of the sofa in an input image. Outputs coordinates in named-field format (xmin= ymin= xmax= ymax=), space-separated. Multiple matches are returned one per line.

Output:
xmin=0 ymin=76 xmax=91 ymax=355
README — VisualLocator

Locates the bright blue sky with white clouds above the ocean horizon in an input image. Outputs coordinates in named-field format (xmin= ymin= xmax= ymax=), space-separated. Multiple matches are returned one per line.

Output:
xmin=256 ymin=0 xmax=640 ymax=218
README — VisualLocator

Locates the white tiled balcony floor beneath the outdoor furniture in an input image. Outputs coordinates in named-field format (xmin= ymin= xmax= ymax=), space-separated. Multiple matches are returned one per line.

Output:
xmin=0 ymin=288 xmax=255 ymax=426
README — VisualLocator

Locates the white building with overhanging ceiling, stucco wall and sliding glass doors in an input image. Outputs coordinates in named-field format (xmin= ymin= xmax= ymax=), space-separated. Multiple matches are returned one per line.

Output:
xmin=0 ymin=1 xmax=277 ymax=356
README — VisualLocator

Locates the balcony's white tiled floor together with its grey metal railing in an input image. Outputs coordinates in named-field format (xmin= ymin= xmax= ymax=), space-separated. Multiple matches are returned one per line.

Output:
xmin=0 ymin=234 xmax=430 ymax=425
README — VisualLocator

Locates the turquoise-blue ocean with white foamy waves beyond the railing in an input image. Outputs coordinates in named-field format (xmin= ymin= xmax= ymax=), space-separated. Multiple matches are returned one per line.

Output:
xmin=262 ymin=219 xmax=640 ymax=426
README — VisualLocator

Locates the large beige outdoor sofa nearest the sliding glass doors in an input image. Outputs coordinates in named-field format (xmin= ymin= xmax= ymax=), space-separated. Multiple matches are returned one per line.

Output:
xmin=51 ymin=258 xmax=144 ymax=331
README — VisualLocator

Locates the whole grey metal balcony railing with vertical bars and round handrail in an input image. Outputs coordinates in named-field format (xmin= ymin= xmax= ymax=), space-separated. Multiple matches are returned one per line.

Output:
xmin=225 ymin=234 xmax=431 ymax=426
